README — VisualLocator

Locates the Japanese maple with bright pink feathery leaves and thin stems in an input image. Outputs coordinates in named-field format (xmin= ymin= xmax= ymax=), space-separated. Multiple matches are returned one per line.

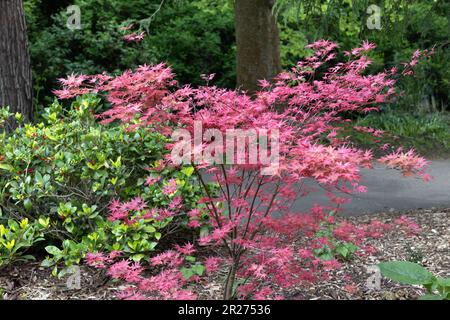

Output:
xmin=55 ymin=40 xmax=428 ymax=298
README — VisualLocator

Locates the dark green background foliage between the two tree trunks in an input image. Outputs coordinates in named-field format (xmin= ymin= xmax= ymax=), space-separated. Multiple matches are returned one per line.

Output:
xmin=27 ymin=0 xmax=235 ymax=105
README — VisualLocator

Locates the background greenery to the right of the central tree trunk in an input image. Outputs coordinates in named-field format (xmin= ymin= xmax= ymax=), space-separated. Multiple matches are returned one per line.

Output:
xmin=277 ymin=0 xmax=450 ymax=112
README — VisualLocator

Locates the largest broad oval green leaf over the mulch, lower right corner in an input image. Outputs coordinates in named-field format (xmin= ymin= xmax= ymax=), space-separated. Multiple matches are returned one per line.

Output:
xmin=378 ymin=261 xmax=435 ymax=285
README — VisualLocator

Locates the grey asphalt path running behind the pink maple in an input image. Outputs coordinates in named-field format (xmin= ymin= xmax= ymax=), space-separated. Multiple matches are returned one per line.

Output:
xmin=292 ymin=160 xmax=450 ymax=215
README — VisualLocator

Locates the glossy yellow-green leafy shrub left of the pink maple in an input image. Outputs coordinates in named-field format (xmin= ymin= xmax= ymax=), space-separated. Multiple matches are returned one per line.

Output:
xmin=0 ymin=96 xmax=201 ymax=276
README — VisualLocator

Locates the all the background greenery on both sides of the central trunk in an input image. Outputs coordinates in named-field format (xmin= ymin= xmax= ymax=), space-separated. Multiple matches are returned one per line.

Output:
xmin=25 ymin=0 xmax=450 ymax=111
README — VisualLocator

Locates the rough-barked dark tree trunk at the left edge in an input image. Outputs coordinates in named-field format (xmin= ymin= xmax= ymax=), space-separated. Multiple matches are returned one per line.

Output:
xmin=0 ymin=0 xmax=33 ymax=127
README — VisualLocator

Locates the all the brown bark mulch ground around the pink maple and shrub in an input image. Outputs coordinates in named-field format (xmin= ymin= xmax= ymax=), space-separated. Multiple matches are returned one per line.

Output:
xmin=0 ymin=209 xmax=450 ymax=300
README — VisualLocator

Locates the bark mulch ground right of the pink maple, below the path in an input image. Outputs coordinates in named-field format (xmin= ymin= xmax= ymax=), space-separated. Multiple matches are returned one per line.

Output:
xmin=298 ymin=209 xmax=450 ymax=300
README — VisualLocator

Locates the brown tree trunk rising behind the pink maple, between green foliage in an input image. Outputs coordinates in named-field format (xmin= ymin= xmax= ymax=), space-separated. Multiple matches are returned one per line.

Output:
xmin=235 ymin=0 xmax=281 ymax=93
